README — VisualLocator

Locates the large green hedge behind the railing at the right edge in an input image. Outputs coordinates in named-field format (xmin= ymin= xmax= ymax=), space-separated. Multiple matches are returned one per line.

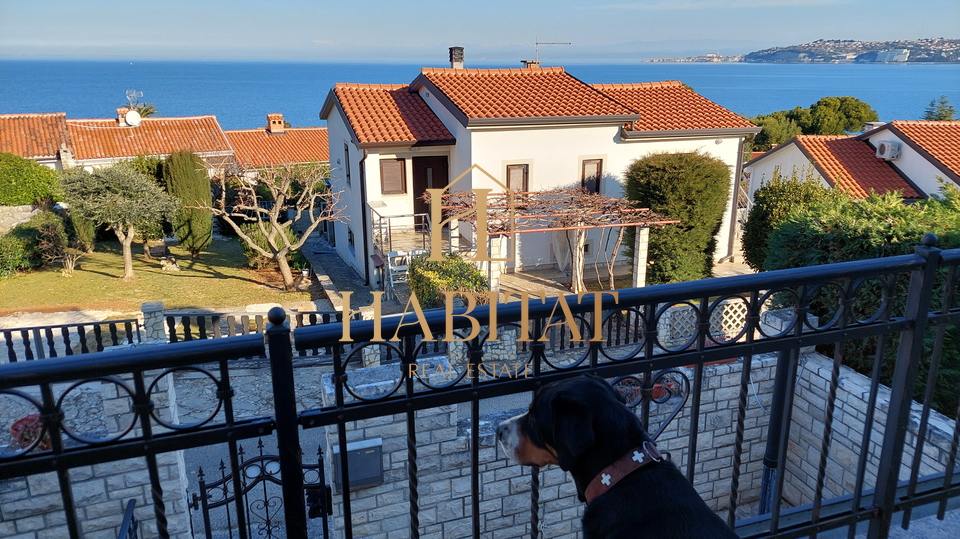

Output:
xmin=764 ymin=185 xmax=960 ymax=417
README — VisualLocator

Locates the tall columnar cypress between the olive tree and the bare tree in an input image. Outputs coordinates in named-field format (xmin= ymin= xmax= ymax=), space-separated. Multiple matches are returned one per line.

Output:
xmin=163 ymin=150 xmax=213 ymax=258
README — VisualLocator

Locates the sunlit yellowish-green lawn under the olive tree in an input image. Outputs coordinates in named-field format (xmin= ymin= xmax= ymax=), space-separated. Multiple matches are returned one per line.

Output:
xmin=0 ymin=239 xmax=310 ymax=316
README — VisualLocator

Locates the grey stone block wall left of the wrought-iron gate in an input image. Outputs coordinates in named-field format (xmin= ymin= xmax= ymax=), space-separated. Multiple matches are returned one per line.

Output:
xmin=0 ymin=362 xmax=190 ymax=539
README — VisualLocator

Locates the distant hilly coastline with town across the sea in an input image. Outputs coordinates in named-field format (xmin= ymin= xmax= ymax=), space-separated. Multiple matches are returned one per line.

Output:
xmin=651 ymin=38 xmax=960 ymax=64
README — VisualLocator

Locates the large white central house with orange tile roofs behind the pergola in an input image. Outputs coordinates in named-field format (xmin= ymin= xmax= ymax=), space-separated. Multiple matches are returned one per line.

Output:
xmin=320 ymin=58 xmax=759 ymax=285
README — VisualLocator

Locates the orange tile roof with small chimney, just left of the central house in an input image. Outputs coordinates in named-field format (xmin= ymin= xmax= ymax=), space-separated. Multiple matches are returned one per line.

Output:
xmin=224 ymin=127 xmax=330 ymax=167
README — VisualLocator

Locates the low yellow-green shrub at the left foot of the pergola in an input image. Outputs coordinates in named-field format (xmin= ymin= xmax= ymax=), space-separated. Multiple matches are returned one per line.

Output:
xmin=409 ymin=254 xmax=490 ymax=309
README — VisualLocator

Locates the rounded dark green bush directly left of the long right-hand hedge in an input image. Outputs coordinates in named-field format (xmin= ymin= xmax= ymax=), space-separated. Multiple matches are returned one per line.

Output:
xmin=743 ymin=168 xmax=847 ymax=271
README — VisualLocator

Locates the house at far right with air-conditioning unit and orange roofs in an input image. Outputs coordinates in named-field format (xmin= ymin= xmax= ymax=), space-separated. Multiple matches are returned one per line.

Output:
xmin=744 ymin=121 xmax=960 ymax=200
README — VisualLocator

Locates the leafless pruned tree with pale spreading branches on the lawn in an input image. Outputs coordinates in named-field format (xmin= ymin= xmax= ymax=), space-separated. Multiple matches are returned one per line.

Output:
xmin=194 ymin=163 xmax=344 ymax=291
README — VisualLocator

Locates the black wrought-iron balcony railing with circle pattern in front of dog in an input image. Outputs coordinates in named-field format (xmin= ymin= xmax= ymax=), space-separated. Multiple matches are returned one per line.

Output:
xmin=0 ymin=238 xmax=960 ymax=539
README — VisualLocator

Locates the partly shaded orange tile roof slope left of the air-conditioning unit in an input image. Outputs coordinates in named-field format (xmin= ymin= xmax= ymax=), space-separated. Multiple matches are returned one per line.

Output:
xmin=784 ymin=135 xmax=920 ymax=198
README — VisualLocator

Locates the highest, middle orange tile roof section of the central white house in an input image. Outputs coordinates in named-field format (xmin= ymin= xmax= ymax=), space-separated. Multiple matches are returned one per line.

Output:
xmin=421 ymin=67 xmax=636 ymax=118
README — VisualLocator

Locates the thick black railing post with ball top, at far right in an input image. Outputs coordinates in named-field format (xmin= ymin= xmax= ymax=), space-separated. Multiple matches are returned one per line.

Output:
xmin=867 ymin=234 xmax=941 ymax=539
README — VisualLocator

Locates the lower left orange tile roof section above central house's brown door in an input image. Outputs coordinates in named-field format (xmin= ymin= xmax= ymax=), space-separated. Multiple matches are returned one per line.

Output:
xmin=333 ymin=83 xmax=454 ymax=144
